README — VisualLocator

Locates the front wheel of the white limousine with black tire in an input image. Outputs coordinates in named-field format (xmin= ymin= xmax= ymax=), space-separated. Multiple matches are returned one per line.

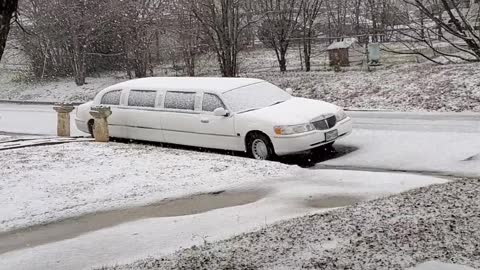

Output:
xmin=246 ymin=132 xmax=276 ymax=160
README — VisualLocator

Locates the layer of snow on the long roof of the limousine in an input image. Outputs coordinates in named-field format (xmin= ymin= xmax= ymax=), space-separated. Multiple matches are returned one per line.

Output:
xmin=103 ymin=77 xmax=264 ymax=93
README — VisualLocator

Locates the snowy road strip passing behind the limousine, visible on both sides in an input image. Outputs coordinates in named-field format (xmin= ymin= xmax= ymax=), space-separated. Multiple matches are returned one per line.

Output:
xmin=0 ymin=103 xmax=480 ymax=135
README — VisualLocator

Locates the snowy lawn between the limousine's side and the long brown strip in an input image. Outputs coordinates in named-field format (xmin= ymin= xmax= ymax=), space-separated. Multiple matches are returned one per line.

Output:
xmin=0 ymin=143 xmax=297 ymax=232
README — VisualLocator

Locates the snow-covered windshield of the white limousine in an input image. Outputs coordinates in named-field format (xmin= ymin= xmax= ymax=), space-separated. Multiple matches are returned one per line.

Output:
xmin=223 ymin=82 xmax=292 ymax=113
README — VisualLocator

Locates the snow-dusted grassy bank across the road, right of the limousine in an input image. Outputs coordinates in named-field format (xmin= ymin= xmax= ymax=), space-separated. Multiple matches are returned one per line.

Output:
xmin=247 ymin=63 xmax=480 ymax=112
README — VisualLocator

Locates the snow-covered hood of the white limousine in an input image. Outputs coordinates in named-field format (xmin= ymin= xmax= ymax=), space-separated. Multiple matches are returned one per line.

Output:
xmin=240 ymin=97 xmax=339 ymax=125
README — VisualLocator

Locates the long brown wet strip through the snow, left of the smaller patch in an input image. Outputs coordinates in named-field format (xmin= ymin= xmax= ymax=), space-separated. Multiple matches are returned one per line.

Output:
xmin=0 ymin=190 xmax=268 ymax=254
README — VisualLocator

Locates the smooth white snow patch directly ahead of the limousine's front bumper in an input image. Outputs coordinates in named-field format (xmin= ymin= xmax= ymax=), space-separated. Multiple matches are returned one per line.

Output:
xmin=316 ymin=129 xmax=480 ymax=177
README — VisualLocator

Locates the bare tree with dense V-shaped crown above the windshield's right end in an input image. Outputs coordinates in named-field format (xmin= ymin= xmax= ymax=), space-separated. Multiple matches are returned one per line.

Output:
xmin=258 ymin=0 xmax=304 ymax=72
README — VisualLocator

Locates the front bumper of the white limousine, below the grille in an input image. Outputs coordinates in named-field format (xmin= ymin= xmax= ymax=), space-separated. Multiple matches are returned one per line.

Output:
xmin=272 ymin=117 xmax=352 ymax=156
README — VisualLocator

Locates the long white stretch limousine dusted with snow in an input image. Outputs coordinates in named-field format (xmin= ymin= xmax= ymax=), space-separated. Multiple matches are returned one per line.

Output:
xmin=75 ymin=78 xmax=352 ymax=160
